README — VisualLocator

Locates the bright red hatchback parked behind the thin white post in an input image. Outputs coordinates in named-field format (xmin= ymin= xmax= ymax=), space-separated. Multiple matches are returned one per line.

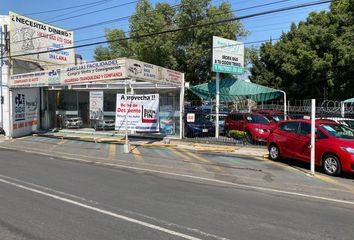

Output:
xmin=267 ymin=119 xmax=354 ymax=175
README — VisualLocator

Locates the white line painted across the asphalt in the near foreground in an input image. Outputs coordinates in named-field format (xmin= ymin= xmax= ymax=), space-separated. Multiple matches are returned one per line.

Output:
xmin=0 ymin=178 xmax=202 ymax=240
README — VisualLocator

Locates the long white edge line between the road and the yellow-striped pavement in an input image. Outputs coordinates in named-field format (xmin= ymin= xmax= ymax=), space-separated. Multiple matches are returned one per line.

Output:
xmin=0 ymin=146 xmax=354 ymax=205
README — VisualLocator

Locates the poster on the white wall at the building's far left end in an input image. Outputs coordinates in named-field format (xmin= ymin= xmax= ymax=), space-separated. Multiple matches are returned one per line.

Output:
xmin=12 ymin=89 xmax=39 ymax=137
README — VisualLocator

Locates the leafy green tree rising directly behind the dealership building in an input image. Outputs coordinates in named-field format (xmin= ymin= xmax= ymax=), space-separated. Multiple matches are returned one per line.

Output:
xmin=95 ymin=0 xmax=247 ymax=85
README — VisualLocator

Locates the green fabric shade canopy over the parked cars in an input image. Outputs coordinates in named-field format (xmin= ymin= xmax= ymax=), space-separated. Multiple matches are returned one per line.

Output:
xmin=189 ymin=78 xmax=283 ymax=102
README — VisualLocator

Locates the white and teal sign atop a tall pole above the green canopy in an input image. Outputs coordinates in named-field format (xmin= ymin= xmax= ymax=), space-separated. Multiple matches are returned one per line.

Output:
xmin=212 ymin=36 xmax=245 ymax=74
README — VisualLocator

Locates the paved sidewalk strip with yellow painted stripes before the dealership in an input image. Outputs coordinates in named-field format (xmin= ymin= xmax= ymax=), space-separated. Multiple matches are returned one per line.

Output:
xmin=0 ymin=136 xmax=354 ymax=203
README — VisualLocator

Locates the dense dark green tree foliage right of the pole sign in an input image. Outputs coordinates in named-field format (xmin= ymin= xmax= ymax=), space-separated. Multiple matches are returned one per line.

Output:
xmin=250 ymin=0 xmax=354 ymax=99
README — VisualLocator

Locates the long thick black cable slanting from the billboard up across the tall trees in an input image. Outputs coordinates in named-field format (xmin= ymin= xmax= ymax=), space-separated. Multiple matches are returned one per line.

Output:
xmin=6 ymin=0 xmax=332 ymax=58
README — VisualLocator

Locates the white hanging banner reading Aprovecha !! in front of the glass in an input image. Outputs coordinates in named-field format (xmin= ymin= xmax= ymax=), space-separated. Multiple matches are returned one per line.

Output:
xmin=115 ymin=94 xmax=159 ymax=132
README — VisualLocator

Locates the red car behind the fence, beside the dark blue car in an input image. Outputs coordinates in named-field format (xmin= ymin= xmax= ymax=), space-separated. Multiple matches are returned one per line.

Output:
xmin=225 ymin=112 xmax=274 ymax=143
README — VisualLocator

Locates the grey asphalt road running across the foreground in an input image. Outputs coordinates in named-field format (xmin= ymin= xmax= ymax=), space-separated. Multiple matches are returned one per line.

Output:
xmin=0 ymin=150 xmax=354 ymax=240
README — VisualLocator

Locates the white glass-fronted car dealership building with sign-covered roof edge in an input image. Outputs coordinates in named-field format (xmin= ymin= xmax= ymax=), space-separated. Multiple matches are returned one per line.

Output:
xmin=0 ymin=13 xmax=184 ymax=138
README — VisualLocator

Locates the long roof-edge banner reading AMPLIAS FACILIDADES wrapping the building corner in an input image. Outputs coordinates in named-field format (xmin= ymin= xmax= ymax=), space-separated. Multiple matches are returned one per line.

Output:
xmin=9 ymin=58 xmax=183 ymax=88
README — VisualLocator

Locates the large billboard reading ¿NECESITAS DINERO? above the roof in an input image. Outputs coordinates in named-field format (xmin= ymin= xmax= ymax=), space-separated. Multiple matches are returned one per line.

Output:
xmin=9 ymin=12 xmax=75 ymax=64
